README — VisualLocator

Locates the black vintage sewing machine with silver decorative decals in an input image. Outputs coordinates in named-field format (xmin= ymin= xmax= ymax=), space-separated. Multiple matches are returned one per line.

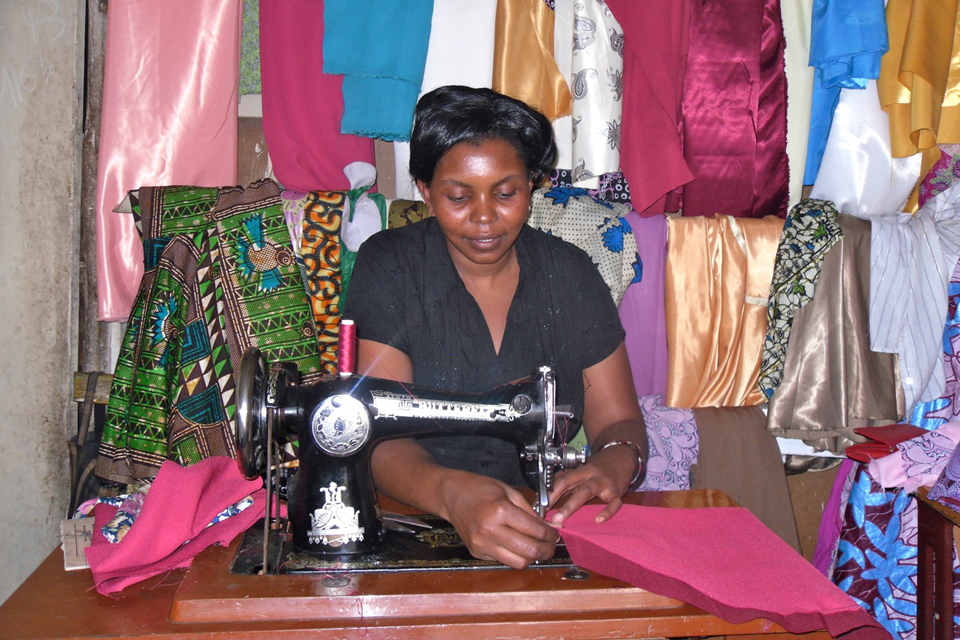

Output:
xmin=236 ymin=349 xmax=586 ymax=566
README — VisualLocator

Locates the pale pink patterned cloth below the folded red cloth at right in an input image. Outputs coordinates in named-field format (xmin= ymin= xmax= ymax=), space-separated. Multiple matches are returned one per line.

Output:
xmin=867 ymin=421 xmax=960 ymax=493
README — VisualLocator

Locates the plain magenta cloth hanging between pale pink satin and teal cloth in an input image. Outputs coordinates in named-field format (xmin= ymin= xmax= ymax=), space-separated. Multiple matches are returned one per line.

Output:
xmin=260 ymin=0 xmax=374 ymax=191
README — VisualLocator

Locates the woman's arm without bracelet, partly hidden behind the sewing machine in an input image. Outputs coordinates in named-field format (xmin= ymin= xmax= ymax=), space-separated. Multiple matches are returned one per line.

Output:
xmin=358 ymin=340 xmax=557 ymax=569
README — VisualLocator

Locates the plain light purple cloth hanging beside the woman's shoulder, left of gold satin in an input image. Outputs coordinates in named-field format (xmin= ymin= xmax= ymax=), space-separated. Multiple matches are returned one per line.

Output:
xmin=619 ymin=211 xmax=667 ymax=397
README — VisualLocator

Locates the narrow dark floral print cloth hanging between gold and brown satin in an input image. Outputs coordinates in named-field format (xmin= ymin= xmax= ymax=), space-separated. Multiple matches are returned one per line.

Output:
xmin=758 ymin=200 xmax=843 ymax=398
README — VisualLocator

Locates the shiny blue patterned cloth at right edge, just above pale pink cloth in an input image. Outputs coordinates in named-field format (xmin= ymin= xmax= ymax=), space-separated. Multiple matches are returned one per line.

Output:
xmin=908 ymin=262 xmax=960 ymax=429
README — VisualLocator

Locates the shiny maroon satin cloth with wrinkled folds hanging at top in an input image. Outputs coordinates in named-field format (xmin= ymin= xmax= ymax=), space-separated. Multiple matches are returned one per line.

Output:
xmin=680 ymin=0 xmax=789 ymax=218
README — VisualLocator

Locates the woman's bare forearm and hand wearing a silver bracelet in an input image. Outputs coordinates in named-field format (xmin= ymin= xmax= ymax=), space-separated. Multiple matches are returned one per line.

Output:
xmin=550 ymin=342 xmax=647 ymax=524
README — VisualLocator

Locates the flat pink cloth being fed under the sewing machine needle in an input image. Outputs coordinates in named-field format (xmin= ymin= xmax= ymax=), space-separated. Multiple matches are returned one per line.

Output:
xmin=560 ymin=505 xmax=890 ymax=638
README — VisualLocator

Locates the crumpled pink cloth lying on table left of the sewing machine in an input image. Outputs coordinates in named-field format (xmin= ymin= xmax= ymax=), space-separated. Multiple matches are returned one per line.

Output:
xmin=85 ymin=457 xmax=266 ymax=594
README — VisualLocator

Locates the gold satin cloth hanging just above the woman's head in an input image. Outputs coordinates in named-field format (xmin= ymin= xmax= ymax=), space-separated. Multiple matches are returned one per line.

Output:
xmin=492 ymin=0 xmax=573 ymax=120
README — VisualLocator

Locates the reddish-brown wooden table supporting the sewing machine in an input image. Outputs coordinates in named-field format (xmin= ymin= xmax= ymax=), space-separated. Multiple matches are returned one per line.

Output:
xmin=0 ymin=491 xmax=830 ymax=640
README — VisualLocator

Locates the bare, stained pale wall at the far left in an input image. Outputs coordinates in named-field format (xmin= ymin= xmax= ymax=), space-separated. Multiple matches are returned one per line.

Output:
xmin=0 ymin=0 xmax=84 ymax=601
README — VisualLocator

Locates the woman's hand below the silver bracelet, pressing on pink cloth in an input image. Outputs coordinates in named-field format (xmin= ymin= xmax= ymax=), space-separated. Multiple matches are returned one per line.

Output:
xmin=548 ymin=446 xmax=637 ymax=525
